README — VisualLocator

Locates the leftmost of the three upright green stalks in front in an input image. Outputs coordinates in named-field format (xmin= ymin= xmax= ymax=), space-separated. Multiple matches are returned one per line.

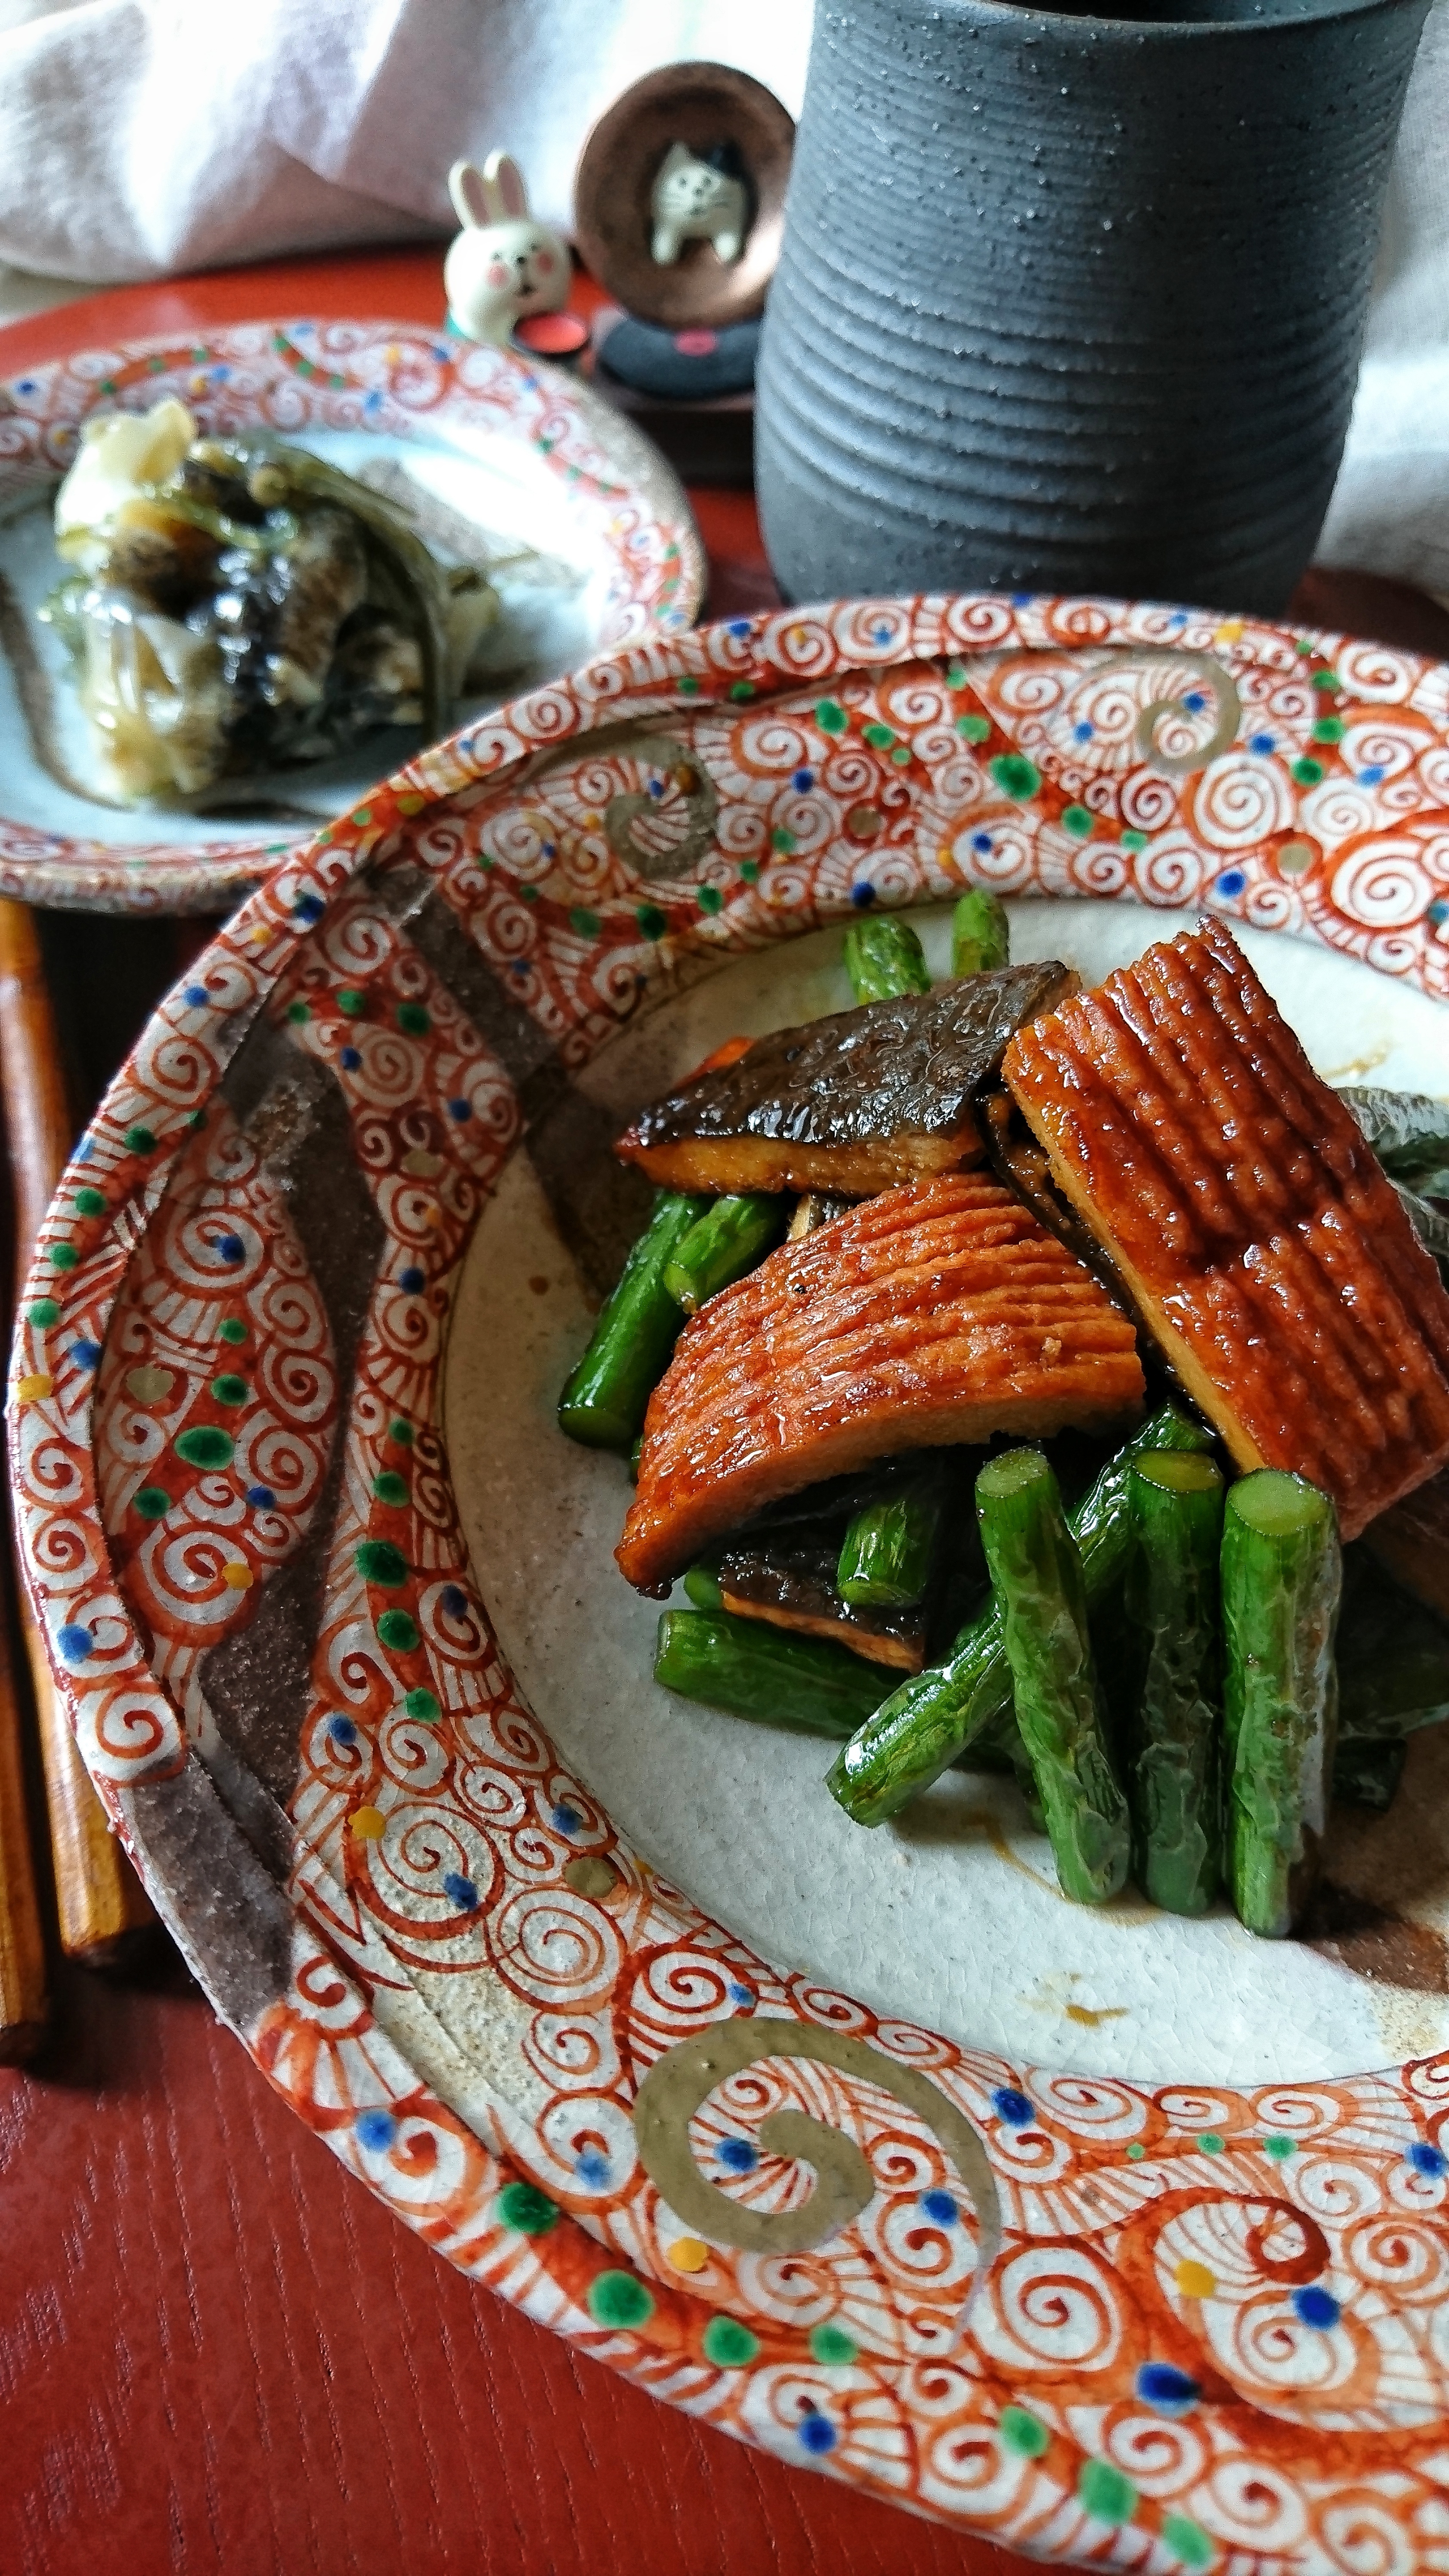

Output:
xmin=977 ymin=1450 xmax=1129 ymax=1906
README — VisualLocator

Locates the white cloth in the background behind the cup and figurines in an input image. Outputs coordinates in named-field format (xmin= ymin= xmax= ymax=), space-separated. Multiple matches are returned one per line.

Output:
xmin=0 ymin=0 xmax=1449 ymax=592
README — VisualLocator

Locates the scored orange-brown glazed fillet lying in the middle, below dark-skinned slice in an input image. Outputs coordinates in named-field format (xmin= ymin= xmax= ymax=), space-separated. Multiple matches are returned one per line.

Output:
xmin=616 ymin=1172 xmax=1142 ymax=1592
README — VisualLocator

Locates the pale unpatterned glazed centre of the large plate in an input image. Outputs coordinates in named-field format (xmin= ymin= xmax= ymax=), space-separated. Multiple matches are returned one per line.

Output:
xmin=443 ymin=901 xmax=1449 ymax=2084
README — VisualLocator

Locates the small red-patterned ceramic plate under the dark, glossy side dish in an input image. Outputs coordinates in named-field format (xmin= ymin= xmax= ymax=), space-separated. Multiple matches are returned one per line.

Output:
xmin=0 ymin=319 xmax=704 ymax=912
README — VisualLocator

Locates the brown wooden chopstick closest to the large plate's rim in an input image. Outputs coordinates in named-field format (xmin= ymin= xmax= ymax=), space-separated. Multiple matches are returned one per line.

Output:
xmin=0 ymin=896 xmax=155 ymax=1968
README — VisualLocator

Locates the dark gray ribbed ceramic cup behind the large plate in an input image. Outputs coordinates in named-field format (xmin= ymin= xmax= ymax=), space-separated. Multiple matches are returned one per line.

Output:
xmin=755 ymin=0 xmax=1426 ymax=616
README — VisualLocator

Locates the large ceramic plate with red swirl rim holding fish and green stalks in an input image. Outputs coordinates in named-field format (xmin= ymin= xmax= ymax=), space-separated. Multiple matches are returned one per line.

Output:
xmin=10 ymin=598 xmax=1449 ymax=2576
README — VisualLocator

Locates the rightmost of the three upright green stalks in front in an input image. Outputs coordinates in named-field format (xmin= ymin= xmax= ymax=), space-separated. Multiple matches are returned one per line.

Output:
xmin=1222 ymin=1468 xmax=1341 ymax=1940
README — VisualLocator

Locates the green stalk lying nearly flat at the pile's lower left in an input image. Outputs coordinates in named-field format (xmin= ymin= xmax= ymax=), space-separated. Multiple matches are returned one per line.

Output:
xmin=655 ymin=1610 xmax=884 ymax=1739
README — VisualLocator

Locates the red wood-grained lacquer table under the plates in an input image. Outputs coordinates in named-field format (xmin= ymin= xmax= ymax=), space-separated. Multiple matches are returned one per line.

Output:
xmin=0 ymin=252 xmax=1449 ymax=2576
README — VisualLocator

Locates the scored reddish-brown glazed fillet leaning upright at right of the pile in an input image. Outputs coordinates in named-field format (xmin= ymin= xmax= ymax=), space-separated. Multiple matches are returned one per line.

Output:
xmin=1003 ymin=922 xmax=1449 ymax=1538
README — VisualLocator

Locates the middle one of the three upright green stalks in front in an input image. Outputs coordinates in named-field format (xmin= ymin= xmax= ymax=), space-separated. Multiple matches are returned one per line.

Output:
xmin=1127 ymin=1450 xmax=1222 ymax=1914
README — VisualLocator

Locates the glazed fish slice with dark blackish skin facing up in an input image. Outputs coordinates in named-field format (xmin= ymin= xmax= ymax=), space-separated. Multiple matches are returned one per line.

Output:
xmin=613 ymin=961 xmax=1078 ymax=1198
